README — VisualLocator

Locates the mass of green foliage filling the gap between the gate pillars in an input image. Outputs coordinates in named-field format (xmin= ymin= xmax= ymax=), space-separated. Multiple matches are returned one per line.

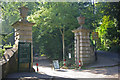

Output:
xmin=27 ymin=2 xmax=96 ymax=59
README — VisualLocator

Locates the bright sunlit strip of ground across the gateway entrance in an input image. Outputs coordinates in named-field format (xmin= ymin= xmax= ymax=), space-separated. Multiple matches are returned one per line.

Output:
xmin=34 ymin=60 xmax=118 ymax=78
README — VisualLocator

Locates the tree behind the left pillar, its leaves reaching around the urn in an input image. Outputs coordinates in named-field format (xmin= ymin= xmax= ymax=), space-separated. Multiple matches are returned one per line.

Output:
xmin=0 ymin=2 xmax=37 ymax=45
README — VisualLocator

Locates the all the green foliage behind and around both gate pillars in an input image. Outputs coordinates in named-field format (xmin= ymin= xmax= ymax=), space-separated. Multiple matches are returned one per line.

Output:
xmin=0 ymin=2 xmax=120 ymax=60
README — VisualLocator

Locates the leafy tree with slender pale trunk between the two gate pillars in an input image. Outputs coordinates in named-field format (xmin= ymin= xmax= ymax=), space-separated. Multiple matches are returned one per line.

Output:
xmin=28 ymin=2 xmax=96 ymax=59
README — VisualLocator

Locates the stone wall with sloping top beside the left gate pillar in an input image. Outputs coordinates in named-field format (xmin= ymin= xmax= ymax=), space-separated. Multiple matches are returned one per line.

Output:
xmin=2 ymin=48 xmax=18 ymax=78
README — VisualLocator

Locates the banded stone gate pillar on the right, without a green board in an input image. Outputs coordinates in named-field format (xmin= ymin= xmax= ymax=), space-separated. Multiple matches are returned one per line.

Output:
xmin=72 ymin=17 xmax=95 ymax=66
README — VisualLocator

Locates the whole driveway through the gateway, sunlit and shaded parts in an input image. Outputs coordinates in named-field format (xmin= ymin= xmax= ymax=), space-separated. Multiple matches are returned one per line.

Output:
xmin=33 ymin=52 xmax=118 ymax=79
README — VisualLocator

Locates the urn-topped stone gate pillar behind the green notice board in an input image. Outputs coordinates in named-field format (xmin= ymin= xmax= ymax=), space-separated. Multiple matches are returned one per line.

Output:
xmin=12 ymin=7 xmax=35 ymax=71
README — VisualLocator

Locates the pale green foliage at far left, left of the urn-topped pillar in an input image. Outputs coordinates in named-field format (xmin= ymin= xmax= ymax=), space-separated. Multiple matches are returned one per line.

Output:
xmin=0 ymin=2 xmax=19 ymax=44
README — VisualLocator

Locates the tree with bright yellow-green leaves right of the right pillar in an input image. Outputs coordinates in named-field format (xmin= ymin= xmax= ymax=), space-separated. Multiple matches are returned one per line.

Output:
xmin=96 ymin=2 xmax=120 ymax=52
